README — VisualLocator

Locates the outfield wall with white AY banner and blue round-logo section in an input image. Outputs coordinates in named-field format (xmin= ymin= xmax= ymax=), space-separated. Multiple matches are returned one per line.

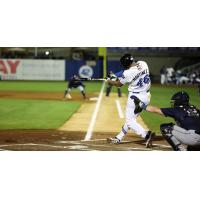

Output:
xmin=0 ymin=59 xmax=103 ymax=81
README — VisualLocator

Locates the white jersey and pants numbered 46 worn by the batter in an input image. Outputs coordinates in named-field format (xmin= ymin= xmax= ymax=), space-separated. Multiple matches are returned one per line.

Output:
xmin=116 ymin=61 xmax=151 ymax=140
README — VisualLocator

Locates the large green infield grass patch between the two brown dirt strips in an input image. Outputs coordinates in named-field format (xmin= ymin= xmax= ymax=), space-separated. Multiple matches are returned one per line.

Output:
xmin=0 ymin=99 xmax=81 ymax=129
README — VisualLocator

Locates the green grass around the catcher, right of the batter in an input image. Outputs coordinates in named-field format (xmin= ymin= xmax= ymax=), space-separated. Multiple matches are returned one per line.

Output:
xmin=141 ymin=85 xmax=200 ymax=133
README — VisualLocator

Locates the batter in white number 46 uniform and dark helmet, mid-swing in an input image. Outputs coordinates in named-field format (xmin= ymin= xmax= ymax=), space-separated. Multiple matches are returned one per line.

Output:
xmin=107 ymin=54 xmax=155 ymax=147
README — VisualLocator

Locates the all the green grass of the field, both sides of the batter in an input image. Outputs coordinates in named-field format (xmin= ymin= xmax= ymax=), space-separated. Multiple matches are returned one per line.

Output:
xmin=0 ymin=81 xmax=200 ymax=132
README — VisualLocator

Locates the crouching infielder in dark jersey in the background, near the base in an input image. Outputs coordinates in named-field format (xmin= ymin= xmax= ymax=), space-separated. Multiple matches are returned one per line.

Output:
xmin=64 ymin=75 xmax=86 ymax=99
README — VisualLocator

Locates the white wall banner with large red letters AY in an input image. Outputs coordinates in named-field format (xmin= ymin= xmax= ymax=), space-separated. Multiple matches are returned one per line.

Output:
xmin=0 ymin=59 xmax=65 ymax=80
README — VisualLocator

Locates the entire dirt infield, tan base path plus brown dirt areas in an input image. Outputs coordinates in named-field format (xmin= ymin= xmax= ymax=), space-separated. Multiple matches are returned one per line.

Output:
xmin=0 ymin=92 xmax=171 ymax=151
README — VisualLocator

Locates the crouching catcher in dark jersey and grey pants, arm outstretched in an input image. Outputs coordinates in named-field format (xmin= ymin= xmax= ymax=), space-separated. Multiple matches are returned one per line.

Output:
xmin=146 ymin=91 xmax=200 ymax=151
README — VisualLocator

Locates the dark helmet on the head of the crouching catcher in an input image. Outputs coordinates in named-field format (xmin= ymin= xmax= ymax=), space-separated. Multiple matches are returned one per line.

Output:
xmin=171 ymin=91 xmax=190 ymax=107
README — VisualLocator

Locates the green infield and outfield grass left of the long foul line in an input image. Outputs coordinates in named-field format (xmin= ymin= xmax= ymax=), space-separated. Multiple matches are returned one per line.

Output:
xmin=0 ymin=81 xmax=102 ymax=129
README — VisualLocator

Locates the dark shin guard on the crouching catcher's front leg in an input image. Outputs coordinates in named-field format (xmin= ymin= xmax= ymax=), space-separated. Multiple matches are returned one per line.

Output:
xmin=160 ymin=123 xmax=186 ymax=151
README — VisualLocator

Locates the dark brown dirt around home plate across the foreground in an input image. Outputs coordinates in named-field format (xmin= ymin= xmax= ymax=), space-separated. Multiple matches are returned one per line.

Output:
xmin=0 ymin=130 xmax=171 ymax=151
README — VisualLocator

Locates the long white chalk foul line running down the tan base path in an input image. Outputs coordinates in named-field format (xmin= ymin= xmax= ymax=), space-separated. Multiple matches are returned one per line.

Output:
xmin=84 ymin=81 xmax=105 ymax=141
